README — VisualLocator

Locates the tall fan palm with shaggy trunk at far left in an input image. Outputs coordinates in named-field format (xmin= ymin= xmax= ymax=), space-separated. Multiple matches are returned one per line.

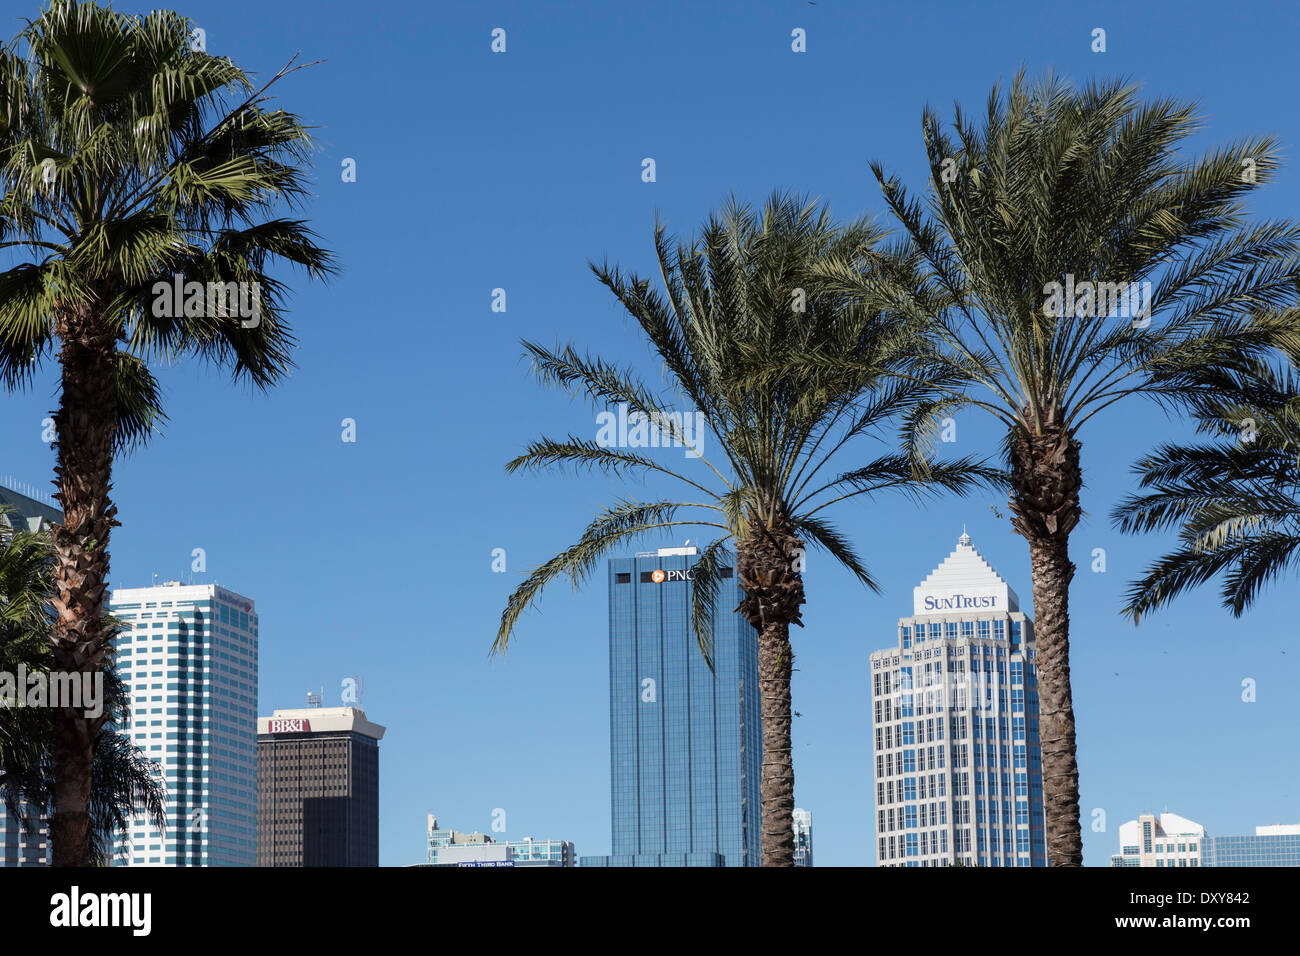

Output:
xmin=0 ymin=0 xmax=332 ymax=865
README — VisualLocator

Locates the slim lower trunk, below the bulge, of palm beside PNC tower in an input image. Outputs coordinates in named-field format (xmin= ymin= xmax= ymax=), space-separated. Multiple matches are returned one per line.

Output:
xmin=758 ymin=622 xmax=794 ymax=866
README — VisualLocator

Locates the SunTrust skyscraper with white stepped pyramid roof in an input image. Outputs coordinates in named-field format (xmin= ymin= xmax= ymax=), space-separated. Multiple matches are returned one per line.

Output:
xmin=871 ymin=532 xmax=1047 ymax=866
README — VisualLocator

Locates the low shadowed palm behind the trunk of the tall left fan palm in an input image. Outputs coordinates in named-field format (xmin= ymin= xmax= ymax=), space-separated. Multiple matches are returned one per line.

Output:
xmin=0 ymin=509 xmax=165 ymax=866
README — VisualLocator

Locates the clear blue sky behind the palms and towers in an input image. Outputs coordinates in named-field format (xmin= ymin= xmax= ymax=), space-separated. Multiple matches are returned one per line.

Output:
xmin=0 ymin=0 xmax=1300 ymax=865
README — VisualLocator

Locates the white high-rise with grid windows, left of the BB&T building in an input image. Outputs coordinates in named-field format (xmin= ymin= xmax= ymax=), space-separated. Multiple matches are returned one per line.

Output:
xmin=109 ymin=581 xmax=257 ymax=866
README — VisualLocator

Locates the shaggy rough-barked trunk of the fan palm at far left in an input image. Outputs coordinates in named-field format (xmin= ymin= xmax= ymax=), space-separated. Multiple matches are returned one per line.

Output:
xmin=49 ymin=307 xmax=117 ymax=866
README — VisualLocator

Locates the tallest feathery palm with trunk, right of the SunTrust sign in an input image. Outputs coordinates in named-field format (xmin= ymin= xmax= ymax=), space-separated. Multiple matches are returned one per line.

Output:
xmin=818 ymin=72 xmax=1300 ymax=866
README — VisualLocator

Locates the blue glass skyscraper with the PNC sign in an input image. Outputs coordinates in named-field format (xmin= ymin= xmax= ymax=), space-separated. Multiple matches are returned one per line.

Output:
xmin=582 ymin=548 xmax=763 ymax=866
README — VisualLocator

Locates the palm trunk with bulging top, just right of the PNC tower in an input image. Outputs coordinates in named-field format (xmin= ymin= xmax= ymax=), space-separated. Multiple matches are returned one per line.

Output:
xmin=736 ymin=510 xmax=803 ymax=866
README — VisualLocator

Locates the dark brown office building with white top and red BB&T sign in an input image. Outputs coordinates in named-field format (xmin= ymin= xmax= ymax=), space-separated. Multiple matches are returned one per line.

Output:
xmin=257 ymin=708 xmax=385 ymax=866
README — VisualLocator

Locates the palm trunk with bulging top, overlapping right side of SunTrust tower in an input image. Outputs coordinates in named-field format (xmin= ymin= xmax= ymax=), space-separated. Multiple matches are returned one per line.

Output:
xmin=1011 ymin=428 xmax=1083 ymax=866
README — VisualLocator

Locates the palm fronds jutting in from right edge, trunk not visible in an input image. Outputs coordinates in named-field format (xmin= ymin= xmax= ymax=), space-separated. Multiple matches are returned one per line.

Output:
xmin=1113 ymin=363 xmax=1300 ymax=623
